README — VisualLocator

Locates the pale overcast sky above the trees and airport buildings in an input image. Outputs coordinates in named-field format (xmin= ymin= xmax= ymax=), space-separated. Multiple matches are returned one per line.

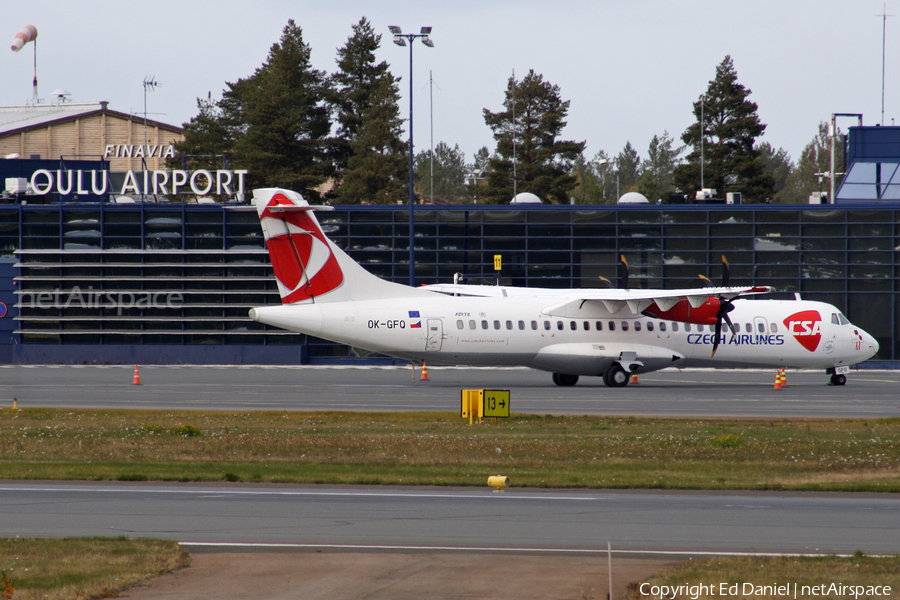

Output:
xmin=0 ymin=0 xmax=900 ymax=166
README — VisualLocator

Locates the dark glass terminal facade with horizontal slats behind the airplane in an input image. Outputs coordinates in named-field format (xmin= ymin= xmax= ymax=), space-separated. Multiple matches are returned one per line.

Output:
xmin=0 ymin=204 xmax=900 ymax=361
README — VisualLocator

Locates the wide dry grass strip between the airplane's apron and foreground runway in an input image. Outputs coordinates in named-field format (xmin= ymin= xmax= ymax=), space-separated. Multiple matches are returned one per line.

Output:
xmin=0 ymin=408 xmax=900 ymax=492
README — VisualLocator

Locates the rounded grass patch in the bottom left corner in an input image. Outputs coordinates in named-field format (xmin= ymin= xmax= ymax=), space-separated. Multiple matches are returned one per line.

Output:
xmin=0 ymin=537 xmax=191 ymax=600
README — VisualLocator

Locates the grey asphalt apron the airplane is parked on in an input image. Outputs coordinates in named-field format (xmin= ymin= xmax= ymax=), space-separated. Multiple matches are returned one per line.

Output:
xmin=0 ymin=365 xmax=900 ymax=418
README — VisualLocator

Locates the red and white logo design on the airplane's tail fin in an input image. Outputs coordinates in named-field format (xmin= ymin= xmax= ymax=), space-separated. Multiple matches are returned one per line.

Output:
xmin=260 ymin=193 xmax=344 ymax=304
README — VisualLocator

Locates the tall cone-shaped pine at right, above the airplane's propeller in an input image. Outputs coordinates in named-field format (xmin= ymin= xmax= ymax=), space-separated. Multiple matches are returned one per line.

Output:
xmin=675 ymin=56 xmax=775 ymax=202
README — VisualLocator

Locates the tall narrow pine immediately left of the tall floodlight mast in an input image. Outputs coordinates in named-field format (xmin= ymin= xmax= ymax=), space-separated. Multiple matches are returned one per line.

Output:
xmin=330 ymin=17 xmax=409 ymax=203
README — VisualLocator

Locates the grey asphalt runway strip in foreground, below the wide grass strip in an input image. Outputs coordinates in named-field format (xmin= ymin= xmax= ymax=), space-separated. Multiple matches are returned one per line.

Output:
xmin=0 ymin=482 xmax=900 ymax=554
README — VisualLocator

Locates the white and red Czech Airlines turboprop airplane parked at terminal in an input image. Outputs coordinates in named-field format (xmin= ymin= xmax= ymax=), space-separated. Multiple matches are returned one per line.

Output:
xmin=249 ymin=188 xmax=878 ymax=387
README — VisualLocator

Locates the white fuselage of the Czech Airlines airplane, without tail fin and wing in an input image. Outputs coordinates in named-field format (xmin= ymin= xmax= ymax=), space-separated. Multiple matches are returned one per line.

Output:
xmin=251 ymin=290 xmax=878 ymax=375
